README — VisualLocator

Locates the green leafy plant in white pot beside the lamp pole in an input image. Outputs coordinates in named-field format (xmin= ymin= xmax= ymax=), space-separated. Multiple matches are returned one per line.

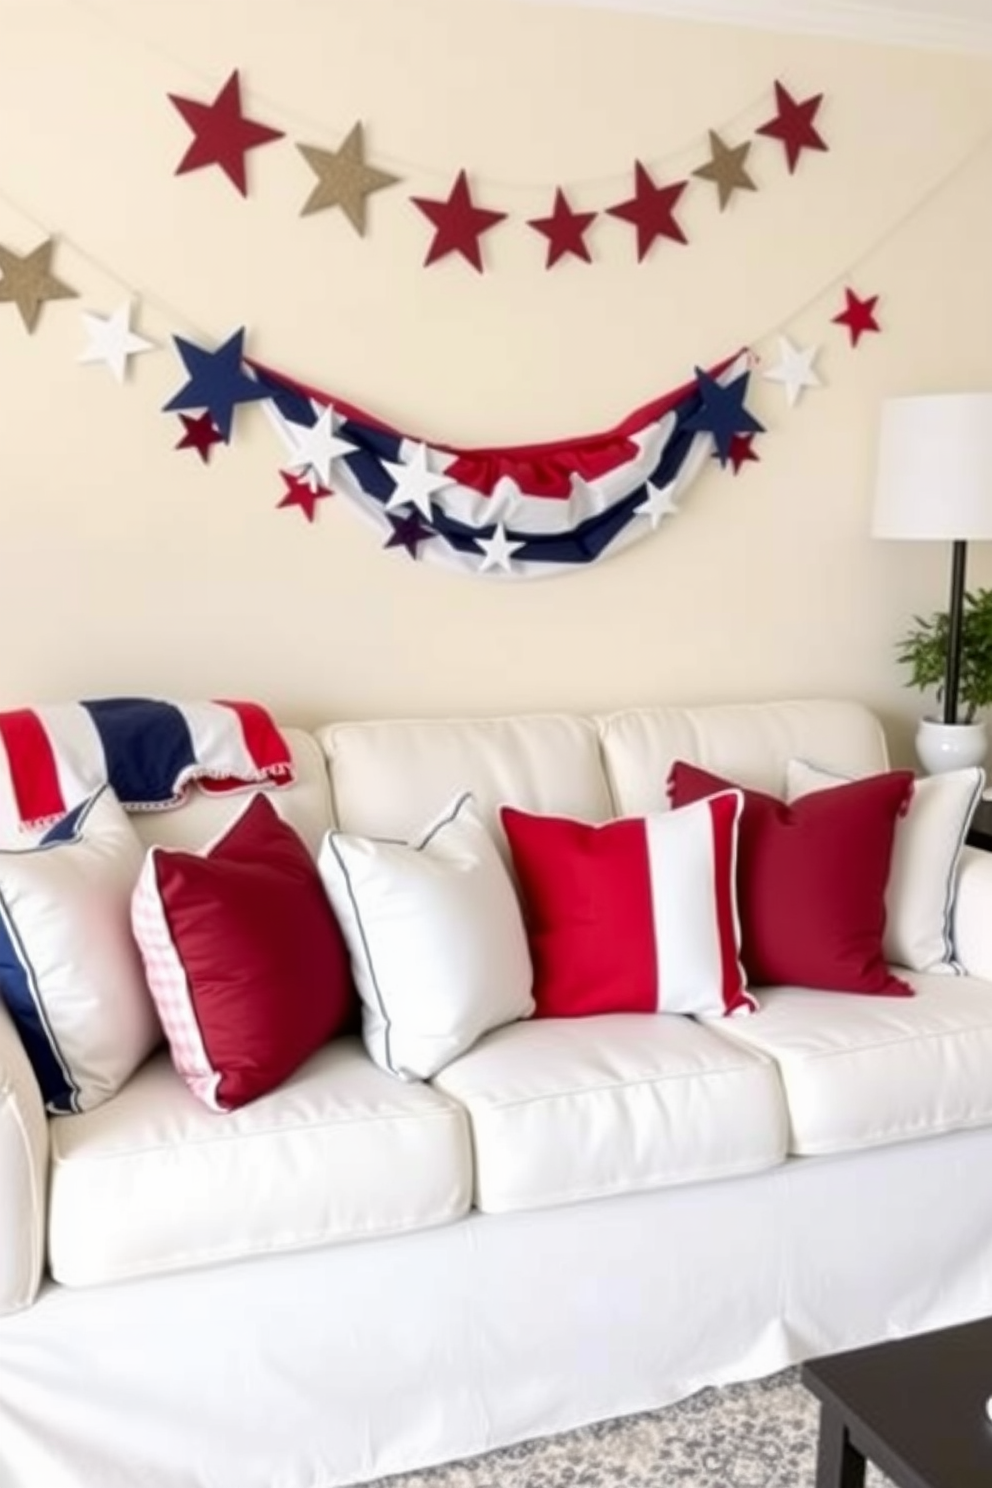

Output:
xmin=897 ymin=589 xmax=992 ymax=774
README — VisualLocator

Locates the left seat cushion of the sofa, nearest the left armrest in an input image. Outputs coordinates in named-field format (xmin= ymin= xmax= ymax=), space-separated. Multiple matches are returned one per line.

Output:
xmin=49 ymin=1037 xmax=471 ymax=1286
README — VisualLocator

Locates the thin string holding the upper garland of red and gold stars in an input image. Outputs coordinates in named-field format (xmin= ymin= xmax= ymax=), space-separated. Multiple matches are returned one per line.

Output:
xmin=65 ymin=0 xmax=797 ymax=196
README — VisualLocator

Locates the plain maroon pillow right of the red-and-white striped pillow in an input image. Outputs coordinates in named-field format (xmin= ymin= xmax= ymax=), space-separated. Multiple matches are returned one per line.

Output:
xmin=668 ymin=760 xmax=913 ymax=997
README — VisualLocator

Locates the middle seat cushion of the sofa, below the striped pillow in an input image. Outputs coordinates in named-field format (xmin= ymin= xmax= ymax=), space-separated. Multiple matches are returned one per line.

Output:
xmin=434 ymin=1013 xmax=787 ymax=1213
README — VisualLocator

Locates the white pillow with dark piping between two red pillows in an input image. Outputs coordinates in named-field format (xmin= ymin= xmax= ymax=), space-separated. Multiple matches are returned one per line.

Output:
xmin=317 ymin=795 xmax=534 ymax=1080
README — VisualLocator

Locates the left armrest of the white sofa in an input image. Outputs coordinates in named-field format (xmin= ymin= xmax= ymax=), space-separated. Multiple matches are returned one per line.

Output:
xmin=0 ymin=1001 xmax=49 ymax=1317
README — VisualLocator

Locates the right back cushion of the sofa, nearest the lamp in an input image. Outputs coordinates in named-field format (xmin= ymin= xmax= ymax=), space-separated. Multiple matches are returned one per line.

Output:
xmin=598 ymin=701 xmax=888 ymax=817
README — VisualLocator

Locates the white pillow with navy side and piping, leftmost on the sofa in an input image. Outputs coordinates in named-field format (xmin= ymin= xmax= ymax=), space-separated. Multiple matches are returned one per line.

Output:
xmin=0 ymin=786 xmax=162 ymax=1113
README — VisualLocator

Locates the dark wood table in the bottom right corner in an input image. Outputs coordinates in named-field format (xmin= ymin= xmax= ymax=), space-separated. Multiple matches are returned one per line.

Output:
xmin=800 ymin=1318 xmax=992 ymax=1488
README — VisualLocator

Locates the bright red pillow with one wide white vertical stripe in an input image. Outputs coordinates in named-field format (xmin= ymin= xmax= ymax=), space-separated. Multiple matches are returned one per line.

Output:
xmin=501 ymin=790 xmax=757 ymax=1018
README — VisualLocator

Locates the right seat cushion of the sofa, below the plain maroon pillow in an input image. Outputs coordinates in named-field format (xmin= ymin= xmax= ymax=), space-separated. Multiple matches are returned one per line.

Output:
xmin=720 ymin=972 xmax=992 ymax=1156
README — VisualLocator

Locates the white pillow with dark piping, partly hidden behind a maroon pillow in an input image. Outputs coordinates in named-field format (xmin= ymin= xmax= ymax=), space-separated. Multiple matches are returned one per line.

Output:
xmin=785 ymin=759 xmax=985 ymax=972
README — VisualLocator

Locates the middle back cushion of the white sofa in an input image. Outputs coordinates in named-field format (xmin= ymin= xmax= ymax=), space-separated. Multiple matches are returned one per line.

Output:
xmin=317 ymin=714 xmax=613 ymax=853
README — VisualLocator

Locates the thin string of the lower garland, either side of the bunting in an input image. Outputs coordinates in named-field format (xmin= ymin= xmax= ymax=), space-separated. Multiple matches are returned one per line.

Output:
xmin=0 ymin=42 xmax=992 ymax=401
